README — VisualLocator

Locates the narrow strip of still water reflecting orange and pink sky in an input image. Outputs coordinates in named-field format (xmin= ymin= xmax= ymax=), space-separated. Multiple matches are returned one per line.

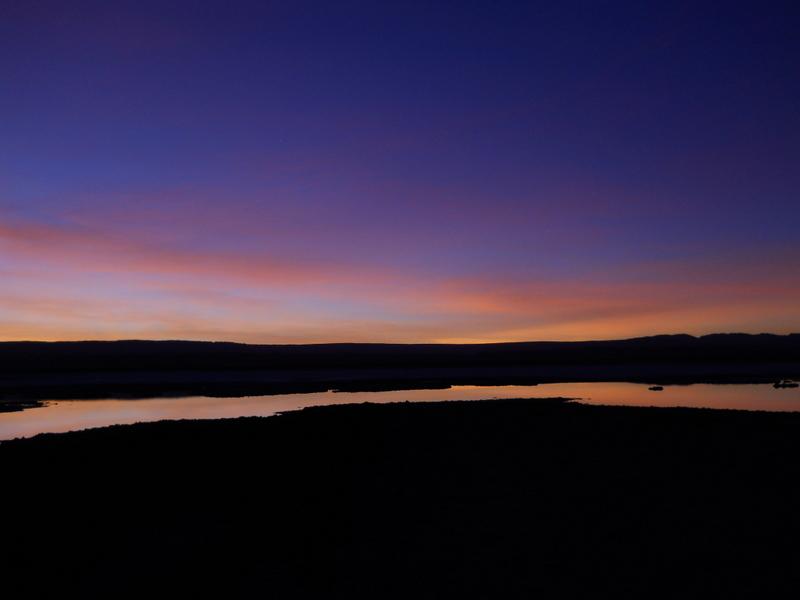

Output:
xmin=0 ymin=383 xmax=800 ymax=440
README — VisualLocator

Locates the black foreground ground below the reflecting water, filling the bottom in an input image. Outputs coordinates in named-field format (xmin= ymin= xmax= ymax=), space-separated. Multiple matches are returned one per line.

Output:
xmin=0 ymin=400 xmax=800 ymax=598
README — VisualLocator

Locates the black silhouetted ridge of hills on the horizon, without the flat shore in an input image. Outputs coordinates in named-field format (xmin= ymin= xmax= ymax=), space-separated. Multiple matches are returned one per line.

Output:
xmin=0 ymin=334 xmax=800 ymax=373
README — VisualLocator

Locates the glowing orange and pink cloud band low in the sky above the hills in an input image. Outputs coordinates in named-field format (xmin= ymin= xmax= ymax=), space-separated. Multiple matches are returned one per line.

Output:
xmin=0 ymin=214 xmax=800 ymax=343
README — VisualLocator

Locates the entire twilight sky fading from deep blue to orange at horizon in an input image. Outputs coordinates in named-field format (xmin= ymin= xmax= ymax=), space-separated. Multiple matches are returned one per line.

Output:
xmin=0 ymin=0 xmax=800 ymax=343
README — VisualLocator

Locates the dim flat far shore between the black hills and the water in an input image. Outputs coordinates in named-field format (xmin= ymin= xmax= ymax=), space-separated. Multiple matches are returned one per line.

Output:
xmin=0 ymin=362 xmax=800 ymax=405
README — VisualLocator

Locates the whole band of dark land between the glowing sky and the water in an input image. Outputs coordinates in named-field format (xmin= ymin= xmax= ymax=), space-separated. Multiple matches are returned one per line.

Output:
xmin=0 ymin=334 xmax=800 ymax=401
